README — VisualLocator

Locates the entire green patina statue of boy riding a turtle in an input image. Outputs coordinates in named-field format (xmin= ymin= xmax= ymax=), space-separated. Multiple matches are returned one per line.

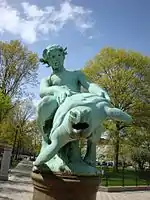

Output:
xmin=33 ymin=45 xmax=132 ymax=175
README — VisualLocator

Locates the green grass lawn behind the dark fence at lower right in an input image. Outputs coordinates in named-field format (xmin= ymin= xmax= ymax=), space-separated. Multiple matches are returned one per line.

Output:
xmin=98 ymin=168 xmax=150 ymax=186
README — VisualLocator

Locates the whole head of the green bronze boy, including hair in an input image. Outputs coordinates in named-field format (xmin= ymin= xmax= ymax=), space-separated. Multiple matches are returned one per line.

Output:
xmin=40 ymin=45 xmax=67 ymax=71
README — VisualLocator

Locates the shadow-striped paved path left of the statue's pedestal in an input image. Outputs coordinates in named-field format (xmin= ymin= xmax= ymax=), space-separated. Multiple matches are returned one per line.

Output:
xmin=0 ymin=160 xmax=33 ymax=200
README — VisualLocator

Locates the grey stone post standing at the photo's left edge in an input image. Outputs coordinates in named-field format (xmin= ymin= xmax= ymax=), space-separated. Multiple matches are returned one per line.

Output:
xmin=0 ymin=147 xmax=12 ymax=181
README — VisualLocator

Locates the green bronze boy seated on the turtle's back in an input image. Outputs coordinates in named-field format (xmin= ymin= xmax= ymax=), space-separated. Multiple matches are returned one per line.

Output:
xmin=37 ymin=45 xmax=110 ymax=135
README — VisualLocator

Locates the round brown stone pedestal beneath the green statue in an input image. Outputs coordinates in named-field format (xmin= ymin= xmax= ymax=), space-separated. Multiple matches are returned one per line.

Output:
xmin=31 ymin=173 xmax=100 ymax=200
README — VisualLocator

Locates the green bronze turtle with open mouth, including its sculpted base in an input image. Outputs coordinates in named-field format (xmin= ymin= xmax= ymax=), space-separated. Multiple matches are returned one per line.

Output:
xmin=34 ymin=93 xmax=131 ymax=174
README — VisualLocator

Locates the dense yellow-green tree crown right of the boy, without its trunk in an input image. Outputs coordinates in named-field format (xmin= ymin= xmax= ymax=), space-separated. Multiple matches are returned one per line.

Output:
xmin=84 ymin=48 xmax=150 ymax=117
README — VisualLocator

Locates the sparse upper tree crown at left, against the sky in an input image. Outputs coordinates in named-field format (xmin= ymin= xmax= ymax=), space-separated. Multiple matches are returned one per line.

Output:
xmin=0 ymin=40 xmax=38 ymax=98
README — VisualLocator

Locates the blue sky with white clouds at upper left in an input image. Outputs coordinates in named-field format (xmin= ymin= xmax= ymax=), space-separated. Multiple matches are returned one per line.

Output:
xmin=0 ymin=0 xmax=150 ymax=101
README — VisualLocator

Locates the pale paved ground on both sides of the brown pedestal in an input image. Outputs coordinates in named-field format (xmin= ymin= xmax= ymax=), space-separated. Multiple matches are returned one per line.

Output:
xmin=0 ymin=161 xmax=150 ymax=200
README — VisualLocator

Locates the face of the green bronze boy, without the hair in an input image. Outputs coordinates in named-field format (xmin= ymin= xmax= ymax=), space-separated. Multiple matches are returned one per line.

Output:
xmin=48 ymin=49 xmax=65 ymax=71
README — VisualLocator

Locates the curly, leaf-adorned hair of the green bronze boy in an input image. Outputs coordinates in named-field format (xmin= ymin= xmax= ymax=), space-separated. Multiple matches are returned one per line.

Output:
xmin=40 ymin=45 xmax=67 ymax=66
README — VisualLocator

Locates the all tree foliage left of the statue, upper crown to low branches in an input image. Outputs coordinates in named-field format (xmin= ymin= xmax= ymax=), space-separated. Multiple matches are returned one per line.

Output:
xmin=0 ymin=40 xmax=39 ymax=151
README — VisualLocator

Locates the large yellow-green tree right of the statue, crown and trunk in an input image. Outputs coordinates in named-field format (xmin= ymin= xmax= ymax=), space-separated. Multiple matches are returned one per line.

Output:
xmin=83 ymin=48 xmax=150 ymax=170
